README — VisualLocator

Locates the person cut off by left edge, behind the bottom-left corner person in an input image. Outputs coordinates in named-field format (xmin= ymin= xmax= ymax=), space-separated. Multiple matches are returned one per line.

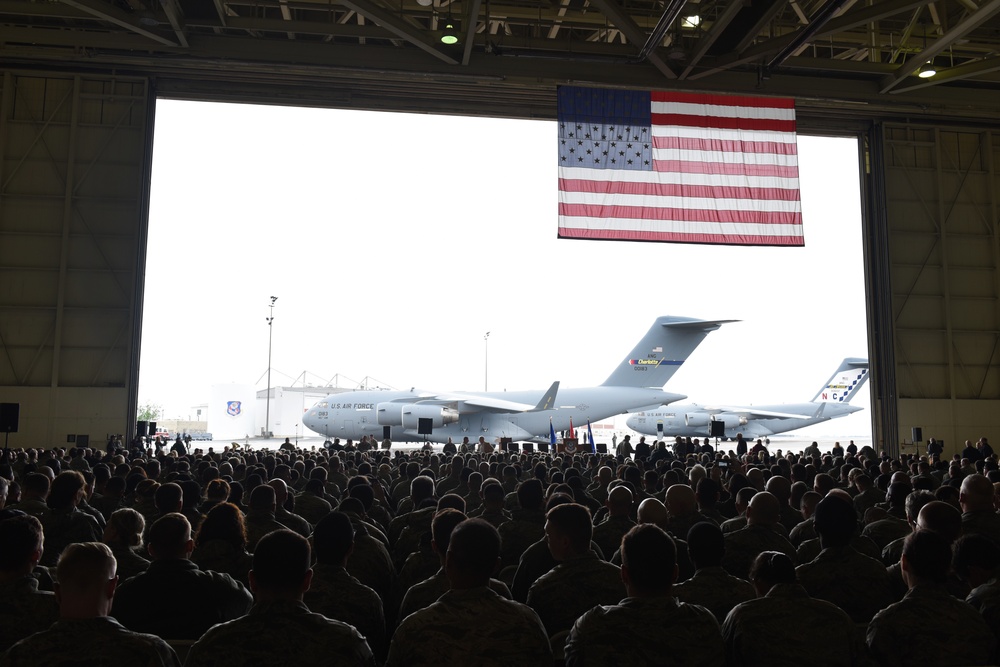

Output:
xmin=0 ymin=513 xmax=59 ymax=652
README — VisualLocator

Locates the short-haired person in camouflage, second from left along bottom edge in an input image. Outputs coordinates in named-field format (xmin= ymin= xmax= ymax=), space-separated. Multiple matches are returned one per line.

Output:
xmin=185 ymin=529 xmax=375 ymax=667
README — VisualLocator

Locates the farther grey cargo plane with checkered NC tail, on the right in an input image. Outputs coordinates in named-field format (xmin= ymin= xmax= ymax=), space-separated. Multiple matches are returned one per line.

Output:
xmin=625 ymin=358 xmax=868 ymax=439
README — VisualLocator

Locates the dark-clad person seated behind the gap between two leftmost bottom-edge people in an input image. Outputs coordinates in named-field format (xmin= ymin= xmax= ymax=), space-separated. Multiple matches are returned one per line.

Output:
xmin=114 ymin=512 xmax=253 ymax=639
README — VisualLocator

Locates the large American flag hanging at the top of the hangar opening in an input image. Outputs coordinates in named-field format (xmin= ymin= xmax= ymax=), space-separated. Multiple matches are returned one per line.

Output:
xmin=559 ymin=86 xmax=804 ymax=246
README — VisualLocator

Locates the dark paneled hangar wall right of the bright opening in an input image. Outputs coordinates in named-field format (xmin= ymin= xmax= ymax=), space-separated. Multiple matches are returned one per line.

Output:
xmin=883 ymin=124 xmax=1000 ymax=455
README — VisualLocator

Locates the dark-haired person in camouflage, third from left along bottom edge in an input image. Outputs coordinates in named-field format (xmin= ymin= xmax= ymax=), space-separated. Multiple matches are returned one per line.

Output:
xmin=386 ymin=519 xmax=552 ymax=667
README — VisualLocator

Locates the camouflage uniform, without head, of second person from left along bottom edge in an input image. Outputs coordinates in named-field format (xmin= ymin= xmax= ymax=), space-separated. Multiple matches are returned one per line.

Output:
xmin=184 ymin=602 xmax=375 ymax=667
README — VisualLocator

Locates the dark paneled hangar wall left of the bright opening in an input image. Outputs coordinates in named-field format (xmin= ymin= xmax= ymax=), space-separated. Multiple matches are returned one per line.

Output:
xmin=0 ymin=70 xmax=152 ymax=446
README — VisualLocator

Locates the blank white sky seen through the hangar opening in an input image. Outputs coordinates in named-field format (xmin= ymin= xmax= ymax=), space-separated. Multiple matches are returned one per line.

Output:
xmin=139 ymin=100 xmax=871 ymax=437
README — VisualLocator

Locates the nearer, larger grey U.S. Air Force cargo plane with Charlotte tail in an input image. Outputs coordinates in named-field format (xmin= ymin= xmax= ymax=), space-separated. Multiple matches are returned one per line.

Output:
xmin=302 ymin=316 xmax=733 ymax=443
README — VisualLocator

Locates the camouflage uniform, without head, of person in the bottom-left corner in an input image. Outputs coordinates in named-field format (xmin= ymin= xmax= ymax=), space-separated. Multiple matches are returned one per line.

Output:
xmin=0 ymin=616 xmax=181 ymax=667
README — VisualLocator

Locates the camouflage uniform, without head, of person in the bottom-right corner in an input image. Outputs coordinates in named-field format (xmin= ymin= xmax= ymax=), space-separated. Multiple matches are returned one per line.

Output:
xmin=868 ymin=584 xmax=996 ymax=667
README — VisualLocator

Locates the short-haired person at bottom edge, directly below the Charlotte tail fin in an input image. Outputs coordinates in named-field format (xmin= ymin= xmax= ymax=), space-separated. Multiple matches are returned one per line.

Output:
xmin=566 ymin=524 xmax=724 ymax=667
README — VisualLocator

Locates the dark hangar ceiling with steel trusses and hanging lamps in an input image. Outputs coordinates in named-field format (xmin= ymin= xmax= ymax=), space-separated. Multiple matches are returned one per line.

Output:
xmin=0 ymin=0 xmax=1000 ymax=118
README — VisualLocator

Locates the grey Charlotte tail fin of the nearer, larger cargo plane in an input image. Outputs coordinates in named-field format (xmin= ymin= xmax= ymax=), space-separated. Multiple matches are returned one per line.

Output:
xmin=601 ymin=316 xmax=736 ymax=388
